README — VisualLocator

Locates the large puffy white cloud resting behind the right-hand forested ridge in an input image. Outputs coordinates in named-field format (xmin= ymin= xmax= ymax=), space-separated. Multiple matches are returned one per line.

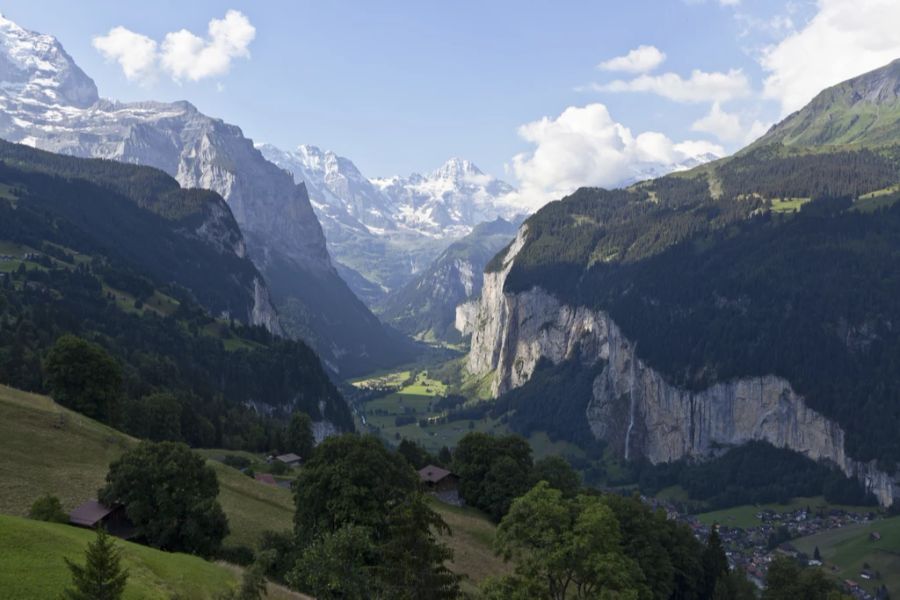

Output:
xmin=509 ymin=104 xmax=725 ymax=210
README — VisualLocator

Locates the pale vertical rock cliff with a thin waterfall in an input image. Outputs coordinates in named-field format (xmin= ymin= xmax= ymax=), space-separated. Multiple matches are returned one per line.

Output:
xmin=456 ymin=227 xmax=900 ymax=506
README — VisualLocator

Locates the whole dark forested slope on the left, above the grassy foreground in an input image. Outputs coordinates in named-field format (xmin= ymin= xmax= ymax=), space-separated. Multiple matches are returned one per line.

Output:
xmin=0 ymin=145 xmax=353 ymax=450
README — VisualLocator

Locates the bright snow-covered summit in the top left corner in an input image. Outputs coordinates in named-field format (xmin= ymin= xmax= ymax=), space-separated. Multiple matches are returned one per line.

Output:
xmin=0 ymin=15 xmax=99 ymax=108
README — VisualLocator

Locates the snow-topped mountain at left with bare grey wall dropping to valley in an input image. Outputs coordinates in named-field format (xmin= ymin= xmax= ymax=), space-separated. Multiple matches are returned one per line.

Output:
xmin=0 ymin=17 xmax=414 ymax=372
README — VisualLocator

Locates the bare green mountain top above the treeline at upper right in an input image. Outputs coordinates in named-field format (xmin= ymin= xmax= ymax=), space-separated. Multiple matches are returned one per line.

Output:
xmin=750 ymin=59 xmax=900 ymax=148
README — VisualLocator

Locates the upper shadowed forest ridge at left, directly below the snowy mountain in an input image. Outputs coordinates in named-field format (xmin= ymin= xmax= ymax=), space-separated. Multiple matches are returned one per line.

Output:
xmin=0 ymin=141 xmax=261 ymax=321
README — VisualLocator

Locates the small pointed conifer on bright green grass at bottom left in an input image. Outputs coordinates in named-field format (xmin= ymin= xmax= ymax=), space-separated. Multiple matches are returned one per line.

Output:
xmin=63 ymin=527 xmax=128 ymax=600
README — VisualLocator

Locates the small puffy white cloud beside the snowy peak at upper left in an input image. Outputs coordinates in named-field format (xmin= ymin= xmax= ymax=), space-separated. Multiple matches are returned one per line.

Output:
xmin=93 ymin=10 xmax=256 ymax=82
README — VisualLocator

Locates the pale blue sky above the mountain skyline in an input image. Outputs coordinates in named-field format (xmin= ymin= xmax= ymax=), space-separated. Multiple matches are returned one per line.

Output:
xmin=2 ymin=0 xmax=900 ymax=207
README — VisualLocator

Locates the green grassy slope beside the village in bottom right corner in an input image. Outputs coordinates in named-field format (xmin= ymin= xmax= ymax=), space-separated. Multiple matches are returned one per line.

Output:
xmin=793 ymin=517 xmax=900 ymax=598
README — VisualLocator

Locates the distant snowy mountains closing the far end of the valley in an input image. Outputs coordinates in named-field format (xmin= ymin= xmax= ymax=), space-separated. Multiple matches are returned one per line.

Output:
xmin=257 ymin=144 xmax=516 ymax=306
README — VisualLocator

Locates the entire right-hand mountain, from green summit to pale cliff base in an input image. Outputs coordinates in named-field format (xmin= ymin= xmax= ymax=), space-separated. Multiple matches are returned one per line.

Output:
xmin=456 ymin=62 xmax=900 ymax=505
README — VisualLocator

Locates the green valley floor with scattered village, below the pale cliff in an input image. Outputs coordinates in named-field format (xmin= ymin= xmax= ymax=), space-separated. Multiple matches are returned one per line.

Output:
xmin=351 ymin=363 xmax=900 ymax=598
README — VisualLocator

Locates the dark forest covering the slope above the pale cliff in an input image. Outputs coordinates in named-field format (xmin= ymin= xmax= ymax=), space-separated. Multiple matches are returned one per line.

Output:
xmin=496 ymin=148 xmax=900 ymax=468
